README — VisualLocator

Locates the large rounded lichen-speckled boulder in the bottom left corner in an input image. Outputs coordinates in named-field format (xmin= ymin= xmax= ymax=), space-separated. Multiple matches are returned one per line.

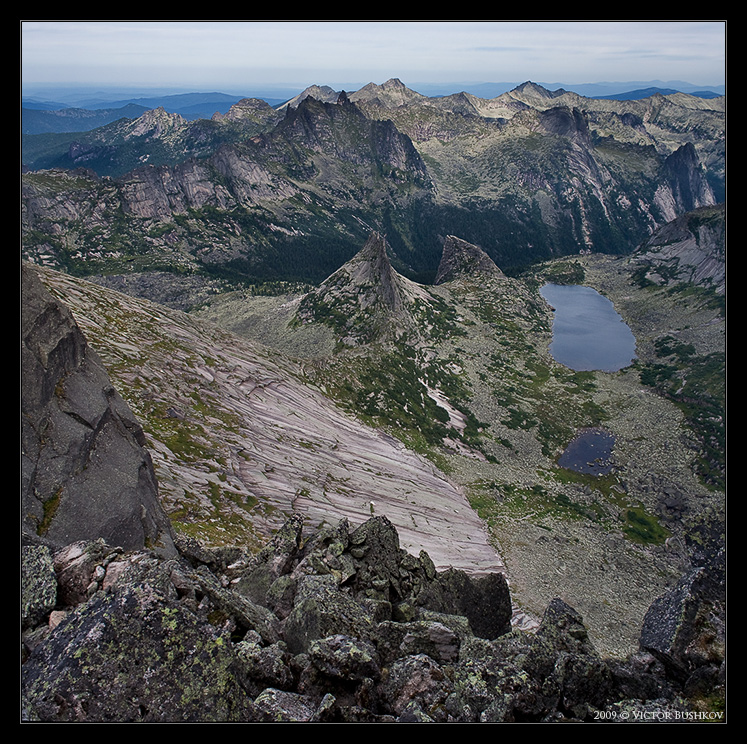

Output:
xmin=22 ymin=564 xmax=251 ymax=723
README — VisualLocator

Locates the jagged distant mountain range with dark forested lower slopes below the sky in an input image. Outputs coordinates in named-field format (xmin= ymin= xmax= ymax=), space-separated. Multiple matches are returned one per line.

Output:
xmin=22 ymin=79 xmax=725 ymax=283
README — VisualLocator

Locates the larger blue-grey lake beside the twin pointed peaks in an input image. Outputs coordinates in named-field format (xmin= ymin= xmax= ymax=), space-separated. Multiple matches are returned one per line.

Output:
xmin=540 ymin=284 xmax=635 ymax=372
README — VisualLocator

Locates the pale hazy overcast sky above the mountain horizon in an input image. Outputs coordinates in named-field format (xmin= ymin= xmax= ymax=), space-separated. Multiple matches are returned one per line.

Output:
xmin=21 ymin=21 xmax=726 ymax=92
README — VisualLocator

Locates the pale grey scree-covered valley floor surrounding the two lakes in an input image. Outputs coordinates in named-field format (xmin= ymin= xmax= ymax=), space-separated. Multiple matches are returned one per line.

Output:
xmin=194 ymin=255 xmax=724 ymax=656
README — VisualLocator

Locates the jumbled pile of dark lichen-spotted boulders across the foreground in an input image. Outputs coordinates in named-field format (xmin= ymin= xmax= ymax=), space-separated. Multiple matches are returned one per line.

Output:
xmin=22 ymin=516 xmax=720 ymax=723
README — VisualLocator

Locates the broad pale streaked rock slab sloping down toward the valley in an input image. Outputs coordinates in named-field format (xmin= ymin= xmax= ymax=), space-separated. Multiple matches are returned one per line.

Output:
xmin=32 ymin=264 xmax=503 ymax=573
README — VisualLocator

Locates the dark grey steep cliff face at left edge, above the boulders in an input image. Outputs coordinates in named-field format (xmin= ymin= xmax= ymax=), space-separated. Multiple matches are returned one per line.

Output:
xmin=21 ymin=267 xmax=174 ymax=553
